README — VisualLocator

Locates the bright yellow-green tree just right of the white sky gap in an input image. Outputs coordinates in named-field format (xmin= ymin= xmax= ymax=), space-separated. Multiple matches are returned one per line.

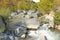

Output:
xmin=37 ymin=0 xmax=54 ymax=13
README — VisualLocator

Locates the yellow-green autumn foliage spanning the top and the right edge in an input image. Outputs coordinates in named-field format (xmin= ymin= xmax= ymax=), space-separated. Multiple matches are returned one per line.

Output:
xmin=0 ymin=0 xmax=60 ymax=24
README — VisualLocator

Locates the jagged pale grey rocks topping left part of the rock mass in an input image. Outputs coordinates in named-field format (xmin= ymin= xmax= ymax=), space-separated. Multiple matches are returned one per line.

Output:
xmin=9 ymin=10 xmax=26 ymax=19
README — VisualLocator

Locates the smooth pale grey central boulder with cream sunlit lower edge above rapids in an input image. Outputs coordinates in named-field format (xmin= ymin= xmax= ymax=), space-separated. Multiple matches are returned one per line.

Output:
xmin=26 ymin=18 xmax=40 ymax=29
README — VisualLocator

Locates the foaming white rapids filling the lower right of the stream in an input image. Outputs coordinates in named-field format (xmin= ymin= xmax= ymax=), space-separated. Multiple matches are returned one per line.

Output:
xmin=26 ymin=24 xmax=60 ymax=40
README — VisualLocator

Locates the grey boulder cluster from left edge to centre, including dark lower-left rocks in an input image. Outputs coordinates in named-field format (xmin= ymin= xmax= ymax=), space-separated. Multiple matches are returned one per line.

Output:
xmin=0 ymin=10 xmax=42 ymax=40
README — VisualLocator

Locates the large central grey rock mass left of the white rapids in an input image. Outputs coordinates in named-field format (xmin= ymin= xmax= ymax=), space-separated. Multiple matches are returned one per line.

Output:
xmin=7 ymin=10 xmax=40 ymax=37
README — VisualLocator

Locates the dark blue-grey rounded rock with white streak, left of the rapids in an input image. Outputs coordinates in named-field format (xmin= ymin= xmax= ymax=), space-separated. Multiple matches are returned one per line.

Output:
xmin=14 ymin=21 xmax=27 ymax=36
